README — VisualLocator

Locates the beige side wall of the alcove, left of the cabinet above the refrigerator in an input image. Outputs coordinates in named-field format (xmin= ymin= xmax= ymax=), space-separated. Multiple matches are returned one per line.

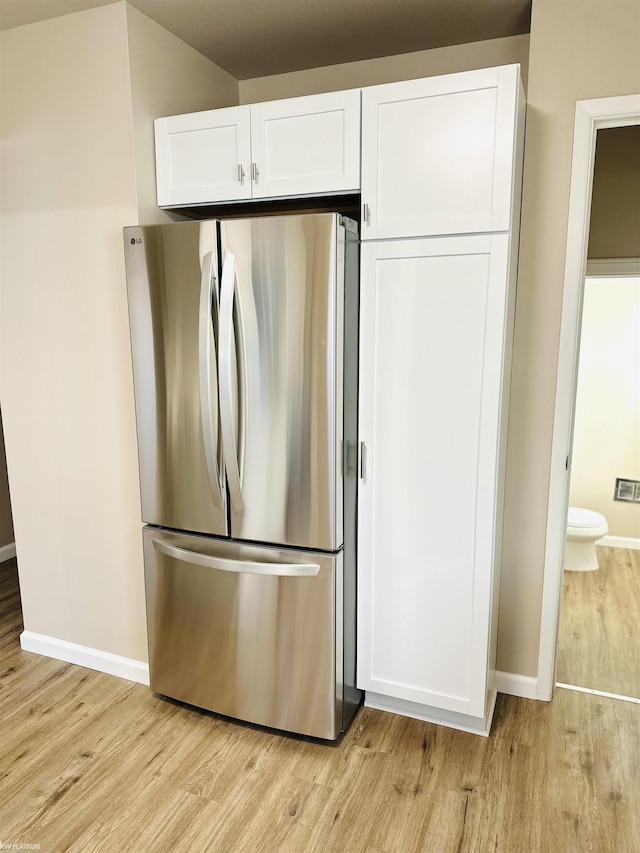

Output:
xmin=127 ymin=5 xmax=238 ymax=225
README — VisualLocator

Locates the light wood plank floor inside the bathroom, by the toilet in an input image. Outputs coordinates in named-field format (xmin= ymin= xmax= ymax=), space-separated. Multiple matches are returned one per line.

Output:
xmin=556 ymin=546 xmax=640 ymax=700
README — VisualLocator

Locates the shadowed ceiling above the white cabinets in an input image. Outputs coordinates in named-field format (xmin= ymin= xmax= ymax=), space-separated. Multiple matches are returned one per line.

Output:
xmin=0 ymin=0 xmax=532 ymax=80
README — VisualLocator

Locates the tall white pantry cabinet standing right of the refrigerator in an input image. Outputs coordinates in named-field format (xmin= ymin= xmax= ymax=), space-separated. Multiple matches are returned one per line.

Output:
xmin=358 ymin=66 xmax=524 ymax=734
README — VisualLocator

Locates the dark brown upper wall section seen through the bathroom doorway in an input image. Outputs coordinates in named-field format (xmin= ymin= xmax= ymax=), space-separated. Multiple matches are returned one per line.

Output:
xmin=589 ymin=123 xmax=640 ymax=258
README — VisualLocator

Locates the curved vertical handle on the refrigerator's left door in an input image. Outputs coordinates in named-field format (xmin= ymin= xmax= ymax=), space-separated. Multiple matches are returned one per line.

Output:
xmin=198 ymin=252 xmax=224 ymax=509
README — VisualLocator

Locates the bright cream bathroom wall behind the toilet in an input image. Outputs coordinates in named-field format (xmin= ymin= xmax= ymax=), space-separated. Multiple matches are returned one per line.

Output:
xmin=569 ymin=276 xmax=640 ymax=539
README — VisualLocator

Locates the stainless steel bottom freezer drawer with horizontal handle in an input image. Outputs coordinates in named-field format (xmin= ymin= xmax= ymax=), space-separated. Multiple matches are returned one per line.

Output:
xmin=143 ymin=527 xmax=355 ymax=739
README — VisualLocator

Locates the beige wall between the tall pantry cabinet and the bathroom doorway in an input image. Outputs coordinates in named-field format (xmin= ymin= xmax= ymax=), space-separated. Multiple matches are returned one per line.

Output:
xmin=498 ymin=0 xmax=640 ymax=676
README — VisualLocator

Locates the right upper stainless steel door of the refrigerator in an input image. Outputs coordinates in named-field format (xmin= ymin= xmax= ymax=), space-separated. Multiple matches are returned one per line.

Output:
xmin=219 ymin=213 xmax=345 ymax=550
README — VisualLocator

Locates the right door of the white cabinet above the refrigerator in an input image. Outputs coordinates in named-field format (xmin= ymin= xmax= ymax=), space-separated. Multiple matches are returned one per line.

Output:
xmin=251 ymin=89 xmax=360 ymax=198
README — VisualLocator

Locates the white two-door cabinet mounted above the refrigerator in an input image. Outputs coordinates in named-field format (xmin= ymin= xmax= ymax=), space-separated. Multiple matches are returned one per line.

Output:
xmin=155 ymin=90 xmax=360 ymax=207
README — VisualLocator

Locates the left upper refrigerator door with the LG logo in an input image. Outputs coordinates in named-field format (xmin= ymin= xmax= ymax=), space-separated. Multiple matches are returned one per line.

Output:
xmin=124 ymin=221 xmax=227 ymax=535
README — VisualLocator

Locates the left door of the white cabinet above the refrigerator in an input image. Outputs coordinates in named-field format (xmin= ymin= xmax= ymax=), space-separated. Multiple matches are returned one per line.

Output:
xmin=155 ymin=106 xmax=251 ymax=207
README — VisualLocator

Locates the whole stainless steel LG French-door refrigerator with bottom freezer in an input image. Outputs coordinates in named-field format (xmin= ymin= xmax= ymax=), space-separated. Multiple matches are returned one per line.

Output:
xmin=124 ymin=213 xmax=361 ymax=739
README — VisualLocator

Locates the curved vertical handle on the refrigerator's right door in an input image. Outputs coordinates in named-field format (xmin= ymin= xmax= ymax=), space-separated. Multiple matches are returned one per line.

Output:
xmin=218 ymin=252 xmax=246 ymax=512
